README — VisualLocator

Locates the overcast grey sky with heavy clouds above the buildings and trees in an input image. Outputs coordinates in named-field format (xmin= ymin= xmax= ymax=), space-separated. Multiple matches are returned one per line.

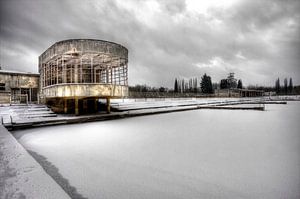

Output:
xmin=0 ymin=0 xmax=300 ymax=87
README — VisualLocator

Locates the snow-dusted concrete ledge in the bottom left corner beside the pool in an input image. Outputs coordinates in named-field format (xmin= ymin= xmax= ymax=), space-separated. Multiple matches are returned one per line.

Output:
xmin=0 ymin=125 xmax=70 ymax=199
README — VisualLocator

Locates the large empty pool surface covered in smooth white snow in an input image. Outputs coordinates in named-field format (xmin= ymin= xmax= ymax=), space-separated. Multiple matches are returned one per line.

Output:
xmin=14 ymin=102 xmax=300 ymax=199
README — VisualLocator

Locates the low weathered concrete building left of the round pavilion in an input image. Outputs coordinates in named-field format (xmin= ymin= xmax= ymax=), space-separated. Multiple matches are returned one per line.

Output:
xmin=0 ymin=70 xmax=40 ymax=104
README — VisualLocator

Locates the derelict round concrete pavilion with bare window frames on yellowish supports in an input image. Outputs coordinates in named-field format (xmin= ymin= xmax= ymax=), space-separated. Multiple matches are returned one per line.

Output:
xmin=39 ymin=39 xmax=128 ymax=115
